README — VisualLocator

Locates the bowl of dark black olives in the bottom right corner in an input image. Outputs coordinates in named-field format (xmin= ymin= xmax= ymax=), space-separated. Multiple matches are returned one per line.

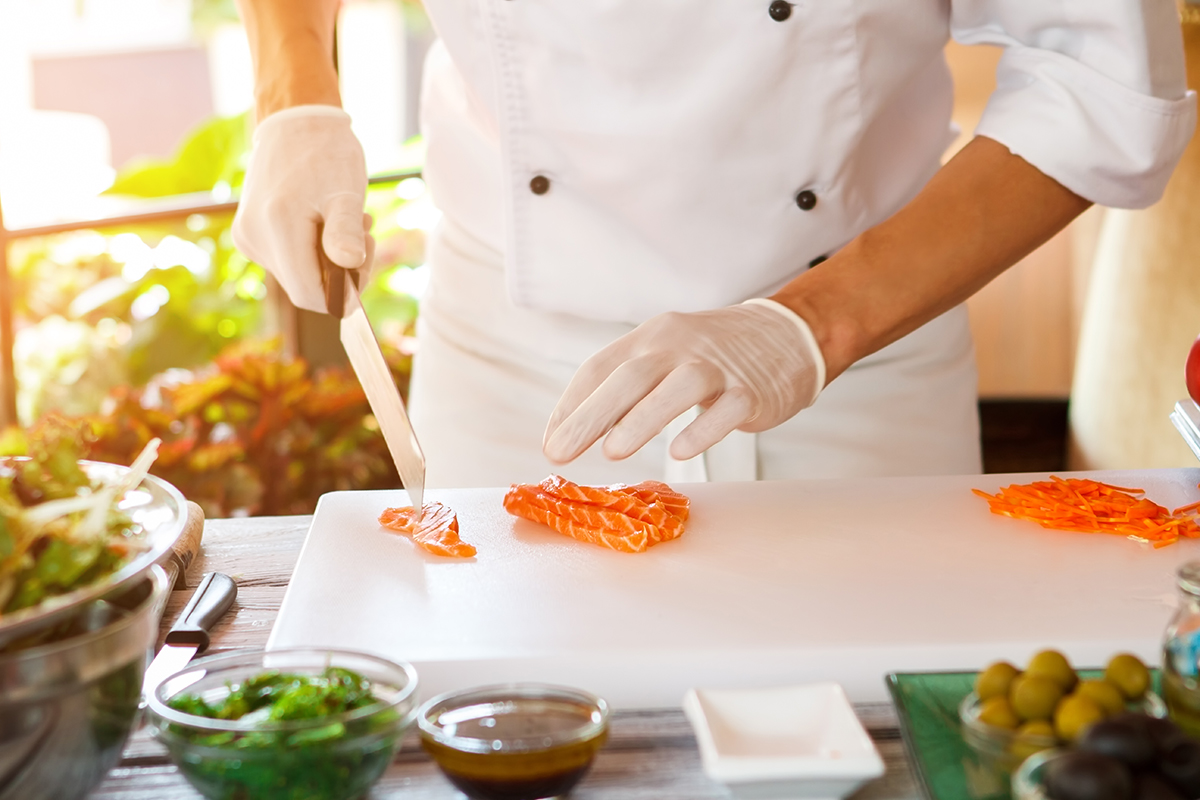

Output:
xmin=1013 ymin=711 xmax=1200 ymax=800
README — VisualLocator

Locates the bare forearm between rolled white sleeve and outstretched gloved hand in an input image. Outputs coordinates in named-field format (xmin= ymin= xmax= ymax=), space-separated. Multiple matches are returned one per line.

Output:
xmin=773 ymin=137 xmax=1091 ymax=380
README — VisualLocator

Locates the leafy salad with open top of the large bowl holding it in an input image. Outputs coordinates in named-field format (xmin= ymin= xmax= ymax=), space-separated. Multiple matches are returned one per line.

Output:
xmin=0 ymin=431 xmax=187 ymax=648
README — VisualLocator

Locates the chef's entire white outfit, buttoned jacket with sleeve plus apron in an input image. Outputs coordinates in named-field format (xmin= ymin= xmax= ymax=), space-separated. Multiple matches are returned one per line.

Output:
xmin=412 ymin=0 xmax=1195 ymax=486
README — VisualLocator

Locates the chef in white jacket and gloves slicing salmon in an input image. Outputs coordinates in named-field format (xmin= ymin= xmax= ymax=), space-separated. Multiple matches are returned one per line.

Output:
xmin=234 ymin=0 xmax=1195 ymax=487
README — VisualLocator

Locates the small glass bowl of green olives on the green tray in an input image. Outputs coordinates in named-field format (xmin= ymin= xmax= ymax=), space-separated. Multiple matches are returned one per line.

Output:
xmin=959 ymin=650 xmax=1166 ymax=772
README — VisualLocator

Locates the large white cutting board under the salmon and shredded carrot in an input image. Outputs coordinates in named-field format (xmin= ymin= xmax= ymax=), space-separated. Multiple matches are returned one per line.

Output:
xmin=268 ymin=469 xmax=1200 ymax=708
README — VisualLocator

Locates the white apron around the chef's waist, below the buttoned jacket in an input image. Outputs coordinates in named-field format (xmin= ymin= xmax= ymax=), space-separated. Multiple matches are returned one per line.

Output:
xmin=409 ymin=215 xmax=980 ymax=487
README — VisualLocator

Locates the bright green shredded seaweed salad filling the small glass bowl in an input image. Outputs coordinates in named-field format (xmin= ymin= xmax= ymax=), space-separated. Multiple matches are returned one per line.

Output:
xmin=160 ymin=667 xmax=404 ymax=800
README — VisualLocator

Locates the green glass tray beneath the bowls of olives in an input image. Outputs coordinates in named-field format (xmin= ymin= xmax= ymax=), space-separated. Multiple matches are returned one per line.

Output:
xmin=887 ymin=669 xmax=1159 ymax=800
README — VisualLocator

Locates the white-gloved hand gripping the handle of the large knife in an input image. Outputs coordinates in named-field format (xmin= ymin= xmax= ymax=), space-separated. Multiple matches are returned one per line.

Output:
xmin=233 ymin=106 xmax=374 ymax=312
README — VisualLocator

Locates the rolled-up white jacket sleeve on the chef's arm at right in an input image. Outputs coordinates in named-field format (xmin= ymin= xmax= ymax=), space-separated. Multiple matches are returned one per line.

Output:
xmin=950 ymin=0 xmax=1196 ymax=209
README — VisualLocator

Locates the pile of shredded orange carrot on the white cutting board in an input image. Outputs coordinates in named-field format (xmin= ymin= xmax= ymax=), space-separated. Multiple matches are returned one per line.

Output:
xmin=971 ymin=475 xmax=1200 ymax=549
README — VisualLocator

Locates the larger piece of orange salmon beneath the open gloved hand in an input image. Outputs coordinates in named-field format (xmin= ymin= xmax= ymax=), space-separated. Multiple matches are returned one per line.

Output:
xmin=504 ymin=475 xmax=689 ymax=553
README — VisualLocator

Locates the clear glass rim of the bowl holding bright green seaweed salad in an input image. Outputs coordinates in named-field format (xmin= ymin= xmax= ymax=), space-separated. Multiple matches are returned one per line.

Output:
xmin=146 ymin=648 xmax=418 ymax=734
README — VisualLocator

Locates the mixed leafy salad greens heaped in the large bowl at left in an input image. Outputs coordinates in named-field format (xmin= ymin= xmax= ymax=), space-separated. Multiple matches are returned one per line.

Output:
xmin=0 ymin=427 xmax=158 ymax=614
